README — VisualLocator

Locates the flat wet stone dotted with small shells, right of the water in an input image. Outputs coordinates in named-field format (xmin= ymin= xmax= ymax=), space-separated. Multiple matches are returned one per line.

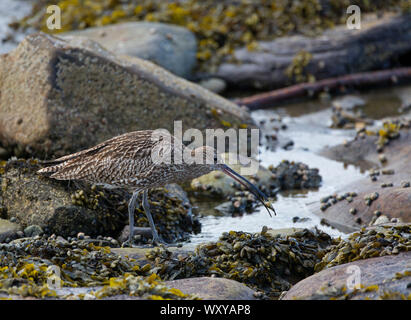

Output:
xmin=318 ymin=119 xmax=411 ymax=228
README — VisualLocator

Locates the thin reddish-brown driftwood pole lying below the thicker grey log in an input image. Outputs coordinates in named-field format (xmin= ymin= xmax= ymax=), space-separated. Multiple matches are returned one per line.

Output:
xmin=234 ymin=67 xmax=411 ymax=110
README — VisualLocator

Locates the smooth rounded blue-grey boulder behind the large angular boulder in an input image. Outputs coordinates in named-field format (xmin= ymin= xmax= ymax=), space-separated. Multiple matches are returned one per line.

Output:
xmin=59 ymin=22 xmax=197 ymax=78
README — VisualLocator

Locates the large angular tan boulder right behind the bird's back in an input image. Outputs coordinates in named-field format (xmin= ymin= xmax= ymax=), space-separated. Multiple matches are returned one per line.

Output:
xmin=0 ymin=33 xmax=252 ymax=158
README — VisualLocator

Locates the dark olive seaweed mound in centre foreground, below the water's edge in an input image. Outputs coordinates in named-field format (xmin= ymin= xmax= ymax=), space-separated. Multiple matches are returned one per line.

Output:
xmin=142 ymin=229 xmax=331 ymax=297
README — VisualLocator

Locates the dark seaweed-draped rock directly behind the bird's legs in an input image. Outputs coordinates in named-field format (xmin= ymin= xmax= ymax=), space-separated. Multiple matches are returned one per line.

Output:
xmin=0 ymin=160 xmax=198 ymax=242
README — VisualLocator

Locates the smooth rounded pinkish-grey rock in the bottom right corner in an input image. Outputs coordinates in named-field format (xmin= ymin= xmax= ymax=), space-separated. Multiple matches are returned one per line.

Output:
xmin=282 ymin=252 xmax=411 ymax=300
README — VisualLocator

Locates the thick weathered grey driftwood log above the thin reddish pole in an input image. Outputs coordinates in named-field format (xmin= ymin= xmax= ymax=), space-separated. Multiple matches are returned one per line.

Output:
xmin=214 ymin=14 xmax=411 ymax=90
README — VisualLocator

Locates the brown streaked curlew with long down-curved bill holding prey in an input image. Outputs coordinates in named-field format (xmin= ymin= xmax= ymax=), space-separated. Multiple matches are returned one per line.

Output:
xmin=38 ymin=130 xmax=275 ymax=245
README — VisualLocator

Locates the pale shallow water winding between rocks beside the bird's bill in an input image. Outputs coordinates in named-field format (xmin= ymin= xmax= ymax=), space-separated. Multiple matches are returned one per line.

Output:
xmin=191 ymin=86 xmax=411 ymax=243
